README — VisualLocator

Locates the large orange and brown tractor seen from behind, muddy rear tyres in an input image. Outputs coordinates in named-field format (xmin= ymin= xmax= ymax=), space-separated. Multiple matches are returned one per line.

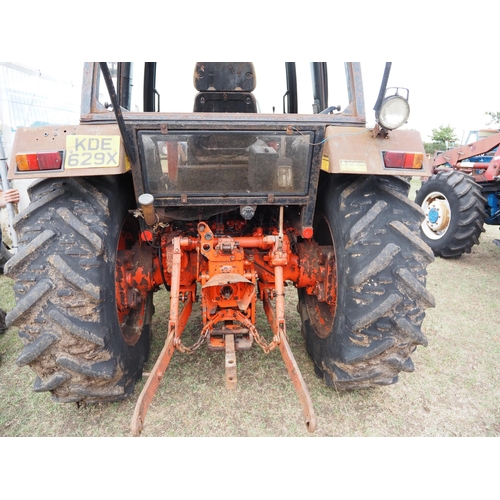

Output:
xmin=5 ymin=62 xmax=435 ymax=436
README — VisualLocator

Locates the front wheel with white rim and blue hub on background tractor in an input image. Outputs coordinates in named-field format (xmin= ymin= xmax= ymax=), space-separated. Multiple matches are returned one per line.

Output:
xmin=415 ymin=169 xmax=486 ymax=258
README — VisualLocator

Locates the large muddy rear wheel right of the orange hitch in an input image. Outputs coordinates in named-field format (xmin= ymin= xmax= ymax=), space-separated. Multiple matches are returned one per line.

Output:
xmin=299 ymin=175 xmax=435 ymax=389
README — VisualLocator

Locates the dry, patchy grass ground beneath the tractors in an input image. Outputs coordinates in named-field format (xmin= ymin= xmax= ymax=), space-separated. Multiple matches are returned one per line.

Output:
xmin=0 ymin=181 xmax=500 ymax=439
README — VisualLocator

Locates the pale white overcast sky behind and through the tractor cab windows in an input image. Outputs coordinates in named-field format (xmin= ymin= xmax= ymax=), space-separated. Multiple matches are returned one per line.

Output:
xmin=7 ymin=59 xmax=500 ymax=146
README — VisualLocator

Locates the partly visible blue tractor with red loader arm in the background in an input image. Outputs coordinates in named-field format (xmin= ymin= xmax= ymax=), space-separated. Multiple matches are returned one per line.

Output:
xmin=415 ymin=129 xmax=500 ymax=258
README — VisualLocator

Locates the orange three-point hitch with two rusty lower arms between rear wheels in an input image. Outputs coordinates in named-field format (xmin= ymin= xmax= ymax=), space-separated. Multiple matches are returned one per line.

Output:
xmin=131 ymin=207 xmax=316 ymax=436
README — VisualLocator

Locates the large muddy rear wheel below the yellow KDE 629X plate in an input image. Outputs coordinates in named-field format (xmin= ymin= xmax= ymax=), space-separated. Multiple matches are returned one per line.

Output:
xmin=5 ymin=176 xmax=152 ymax=403
